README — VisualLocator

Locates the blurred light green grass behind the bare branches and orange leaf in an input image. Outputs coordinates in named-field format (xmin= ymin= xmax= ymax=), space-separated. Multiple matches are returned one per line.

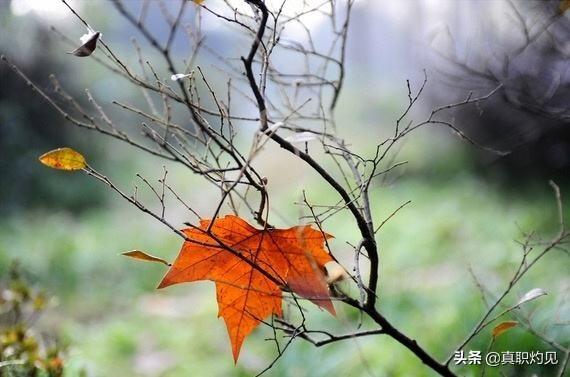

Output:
xmin=0 ymin=134 xmax=568 ymax=376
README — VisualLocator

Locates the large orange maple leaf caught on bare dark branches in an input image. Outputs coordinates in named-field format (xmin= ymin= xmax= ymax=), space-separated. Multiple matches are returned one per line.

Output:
xmin=158 ymin=215 xmax=335 ymax=361
